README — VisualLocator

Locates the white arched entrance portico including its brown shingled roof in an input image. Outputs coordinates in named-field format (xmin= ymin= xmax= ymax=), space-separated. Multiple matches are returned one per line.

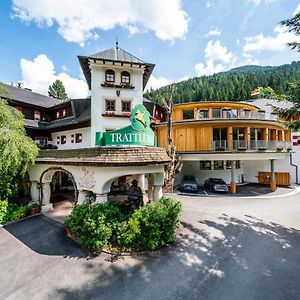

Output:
xmin=29 ymin=147 xmax=169 ymax=211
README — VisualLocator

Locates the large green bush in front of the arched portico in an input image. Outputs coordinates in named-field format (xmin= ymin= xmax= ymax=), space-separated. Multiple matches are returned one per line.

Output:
xmin=65 ymin=198 xmax=181 ymax=251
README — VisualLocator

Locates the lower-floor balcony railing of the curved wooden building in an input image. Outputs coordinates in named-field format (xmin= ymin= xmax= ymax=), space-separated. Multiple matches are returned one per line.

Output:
xmin=212 ymin=140 xmax=291 ymax=151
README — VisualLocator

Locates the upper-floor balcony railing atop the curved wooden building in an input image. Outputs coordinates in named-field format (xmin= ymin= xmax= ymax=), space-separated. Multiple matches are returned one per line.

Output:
xmin=196 ymin=109 xmax=277 ymax=121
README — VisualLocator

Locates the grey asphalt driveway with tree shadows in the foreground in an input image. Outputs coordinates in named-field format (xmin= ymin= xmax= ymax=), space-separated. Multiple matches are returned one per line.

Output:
xmin=0 ymin=195 xmax=300 ymax=300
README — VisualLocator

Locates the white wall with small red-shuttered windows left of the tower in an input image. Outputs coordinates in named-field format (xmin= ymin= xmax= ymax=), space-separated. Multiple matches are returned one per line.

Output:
xmin=51 ymin=127 xmax=91 ymax=150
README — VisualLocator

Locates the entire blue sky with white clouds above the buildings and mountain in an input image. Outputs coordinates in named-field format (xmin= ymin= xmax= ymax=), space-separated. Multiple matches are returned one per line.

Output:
xmin=0 ymin=0 xmax=300 ymax=97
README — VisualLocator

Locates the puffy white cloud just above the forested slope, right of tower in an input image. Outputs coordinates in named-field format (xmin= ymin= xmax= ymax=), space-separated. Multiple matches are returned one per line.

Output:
xmin=195 ymin=41 xmax=235 ymax=76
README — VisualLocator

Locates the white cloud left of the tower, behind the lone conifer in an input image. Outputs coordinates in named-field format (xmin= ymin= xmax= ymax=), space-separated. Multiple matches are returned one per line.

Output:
xmin=20 ymin=54 xmax=88 ymax=98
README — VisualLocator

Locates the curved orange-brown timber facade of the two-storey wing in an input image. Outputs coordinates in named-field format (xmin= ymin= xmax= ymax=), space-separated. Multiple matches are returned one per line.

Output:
xmin=156 ymin=102 xmax=291 ymax=152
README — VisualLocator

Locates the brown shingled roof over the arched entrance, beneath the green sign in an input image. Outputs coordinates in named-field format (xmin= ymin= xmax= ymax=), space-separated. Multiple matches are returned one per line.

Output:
xmin=36 ymin=147 xmax=170 ymax=167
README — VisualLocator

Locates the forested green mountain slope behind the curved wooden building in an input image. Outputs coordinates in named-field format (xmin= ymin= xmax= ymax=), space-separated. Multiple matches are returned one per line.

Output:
xmin=145 ymin=62 xmax=300 ymax=103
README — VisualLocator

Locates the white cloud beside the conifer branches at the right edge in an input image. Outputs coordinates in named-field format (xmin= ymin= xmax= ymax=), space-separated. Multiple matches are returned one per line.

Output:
xmin=243 ymin=25 xmax=300 ymax=53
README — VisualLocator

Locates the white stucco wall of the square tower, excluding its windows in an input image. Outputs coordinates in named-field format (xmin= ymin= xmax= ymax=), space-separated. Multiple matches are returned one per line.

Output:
xmin=91 ymin=63 xmax=144 ymax=146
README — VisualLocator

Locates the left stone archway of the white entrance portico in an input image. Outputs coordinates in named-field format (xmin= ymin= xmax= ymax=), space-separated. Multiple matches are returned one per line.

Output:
xmin=39 ymin=167 xmax=78 ymax=211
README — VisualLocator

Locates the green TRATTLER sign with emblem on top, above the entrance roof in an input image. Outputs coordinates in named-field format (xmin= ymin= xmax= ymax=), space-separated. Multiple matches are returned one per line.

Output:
xmin=96 ymin=104 xmax=156 ymax=147
